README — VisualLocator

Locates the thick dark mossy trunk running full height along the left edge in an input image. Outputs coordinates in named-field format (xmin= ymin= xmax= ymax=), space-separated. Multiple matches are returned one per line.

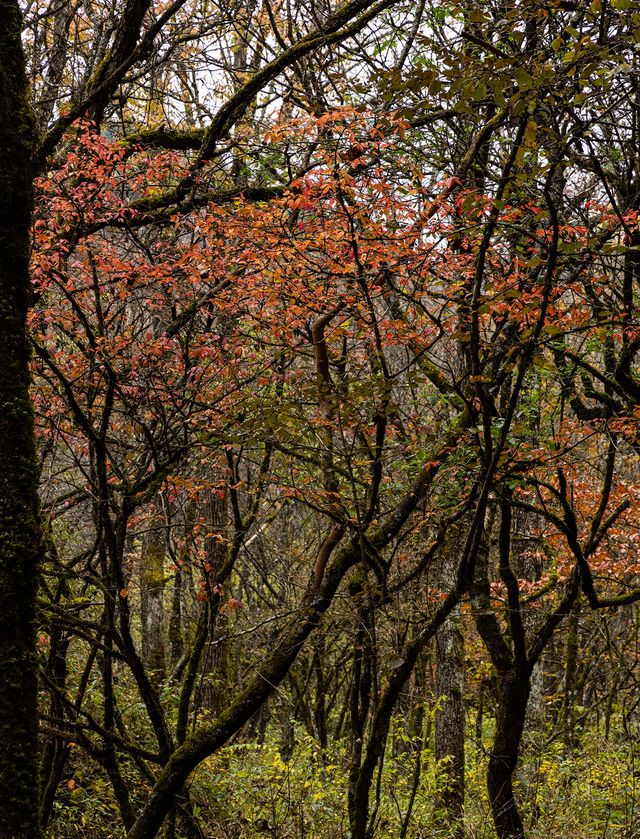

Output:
xmin=0 ymin=0 xmax=41 ymax=839
